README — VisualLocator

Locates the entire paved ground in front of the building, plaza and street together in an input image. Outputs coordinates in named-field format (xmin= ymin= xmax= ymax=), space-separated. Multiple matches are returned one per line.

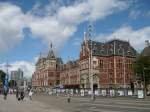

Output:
xmin=0 ymin=95 xmax=150 ymax=112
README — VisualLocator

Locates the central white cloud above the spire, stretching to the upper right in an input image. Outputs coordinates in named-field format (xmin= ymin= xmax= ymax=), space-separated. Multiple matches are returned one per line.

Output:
xmin=28 ymin=0 xmax=127 ymax=52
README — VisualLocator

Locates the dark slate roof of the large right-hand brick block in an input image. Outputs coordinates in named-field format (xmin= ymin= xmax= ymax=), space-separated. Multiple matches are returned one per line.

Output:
xmin=87 ymin=39 xmax=137 ymax=57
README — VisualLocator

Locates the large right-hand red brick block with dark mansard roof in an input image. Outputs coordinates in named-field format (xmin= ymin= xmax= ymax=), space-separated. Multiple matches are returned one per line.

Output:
xmin=80 ymin=34 xmax=137 ymax=88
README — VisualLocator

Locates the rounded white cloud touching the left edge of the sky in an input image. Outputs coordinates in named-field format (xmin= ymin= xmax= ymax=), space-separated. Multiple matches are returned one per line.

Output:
xmin=0 ymin=3 xmax=24 ymax=52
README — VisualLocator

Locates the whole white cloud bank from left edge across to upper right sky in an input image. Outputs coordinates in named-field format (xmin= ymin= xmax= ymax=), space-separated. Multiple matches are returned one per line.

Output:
xmin=0 ymin=0 xmax=128 ymax=52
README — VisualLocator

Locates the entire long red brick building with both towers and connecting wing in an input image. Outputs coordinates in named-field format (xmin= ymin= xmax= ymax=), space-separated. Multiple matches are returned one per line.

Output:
xmin=32 ymin=35 xmax=137 ymax=89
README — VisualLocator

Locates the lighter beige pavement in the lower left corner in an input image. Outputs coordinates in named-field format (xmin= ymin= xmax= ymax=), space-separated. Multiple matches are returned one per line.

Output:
xmin=0 ymin=95 xmax=63 ymax=112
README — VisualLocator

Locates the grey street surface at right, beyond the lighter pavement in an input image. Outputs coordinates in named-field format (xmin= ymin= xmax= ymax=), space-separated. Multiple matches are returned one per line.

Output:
xmin=35 ymin=96 xmax=150 ymax=112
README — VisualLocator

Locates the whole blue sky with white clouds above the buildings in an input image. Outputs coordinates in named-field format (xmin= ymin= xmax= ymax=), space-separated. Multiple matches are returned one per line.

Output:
xmin=0 ymin=0 xmax=150 ymax=77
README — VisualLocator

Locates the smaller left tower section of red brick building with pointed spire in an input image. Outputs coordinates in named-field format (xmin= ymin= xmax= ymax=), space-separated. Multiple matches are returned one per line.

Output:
xmin=32 ymin=46 xmax=63 ymax=91
